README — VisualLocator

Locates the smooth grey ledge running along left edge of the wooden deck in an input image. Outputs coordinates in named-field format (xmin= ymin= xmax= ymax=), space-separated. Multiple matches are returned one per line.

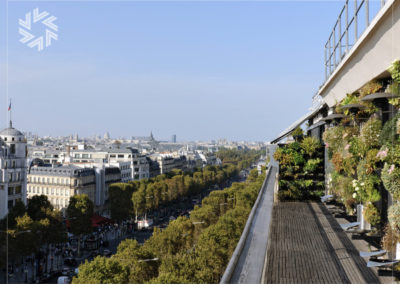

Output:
xmin=229 ymin=167 xmax=276 ymax=284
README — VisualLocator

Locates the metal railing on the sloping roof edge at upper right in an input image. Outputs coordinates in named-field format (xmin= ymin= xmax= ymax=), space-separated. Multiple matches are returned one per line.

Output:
xmin=324 ymin=0 xmax=386 ymax=81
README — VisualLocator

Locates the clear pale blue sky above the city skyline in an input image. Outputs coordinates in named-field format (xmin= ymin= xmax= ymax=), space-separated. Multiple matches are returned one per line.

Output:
xmin=0 ymin=0 xmax=350 ymax=141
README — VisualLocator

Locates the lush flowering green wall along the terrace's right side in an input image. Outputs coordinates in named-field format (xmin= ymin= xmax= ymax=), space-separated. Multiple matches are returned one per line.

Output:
xmin=323 ymin=62 xmax=400 ymax=256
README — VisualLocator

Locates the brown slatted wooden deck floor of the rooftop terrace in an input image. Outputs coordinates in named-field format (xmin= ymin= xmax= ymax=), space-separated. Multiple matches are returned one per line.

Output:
xmin=264 ymin=202 xmax=380 ymax=284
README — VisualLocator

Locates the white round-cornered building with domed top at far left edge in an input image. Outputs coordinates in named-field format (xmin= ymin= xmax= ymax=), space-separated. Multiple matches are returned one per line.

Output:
xmin=0 ymin=120 xmax=27 ymax=219
